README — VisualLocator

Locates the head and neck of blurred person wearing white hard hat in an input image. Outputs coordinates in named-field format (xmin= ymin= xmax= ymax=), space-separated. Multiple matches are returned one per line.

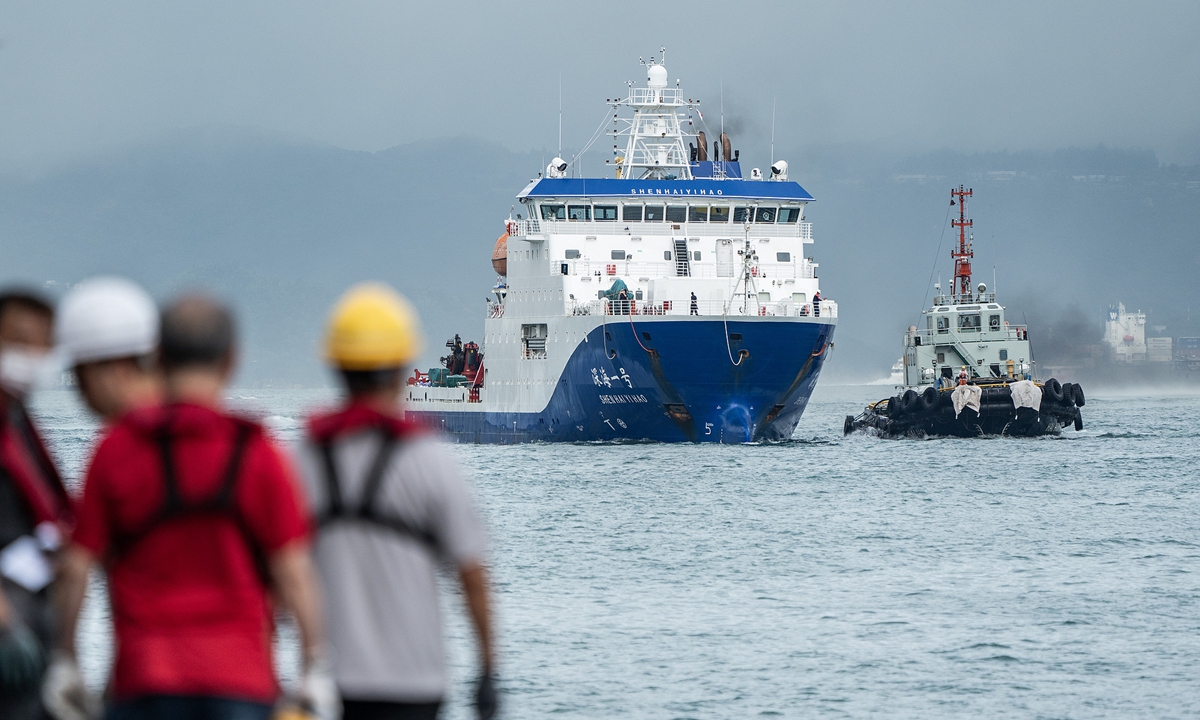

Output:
xmin=54 ymin=277 xmax=162 ymax=422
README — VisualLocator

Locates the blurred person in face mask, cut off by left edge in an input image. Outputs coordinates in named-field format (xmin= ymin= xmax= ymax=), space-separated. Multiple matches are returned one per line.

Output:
xmin=0 ymin=290 xmax=71 ymax=720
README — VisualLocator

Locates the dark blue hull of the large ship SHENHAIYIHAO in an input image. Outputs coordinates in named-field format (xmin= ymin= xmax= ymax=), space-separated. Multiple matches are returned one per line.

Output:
xmin=409 ymin=316 xmax=834 ymax=443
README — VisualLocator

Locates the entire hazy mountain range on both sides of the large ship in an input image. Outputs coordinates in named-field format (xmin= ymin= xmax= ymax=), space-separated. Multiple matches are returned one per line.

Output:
xmin=0 ymin=127 xmax=1200 ymax=385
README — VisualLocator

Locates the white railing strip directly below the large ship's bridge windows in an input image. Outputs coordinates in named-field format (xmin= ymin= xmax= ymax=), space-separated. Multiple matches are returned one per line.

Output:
xmin=514 ymin=220 xmax=812 ymax=242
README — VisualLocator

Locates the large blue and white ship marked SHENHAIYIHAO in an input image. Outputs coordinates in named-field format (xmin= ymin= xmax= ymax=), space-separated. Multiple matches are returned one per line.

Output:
xmin=404 ymin=50 xmax=838 ymax=443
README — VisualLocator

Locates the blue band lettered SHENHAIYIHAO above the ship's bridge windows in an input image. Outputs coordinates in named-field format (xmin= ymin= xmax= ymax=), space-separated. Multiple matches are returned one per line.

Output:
xmin=517 ymin=178 xmax=812 ymax=202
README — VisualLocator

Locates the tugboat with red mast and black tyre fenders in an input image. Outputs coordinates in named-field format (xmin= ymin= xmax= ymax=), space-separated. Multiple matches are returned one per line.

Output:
xmin=844 ymin=185 xmax=1085 ymax=437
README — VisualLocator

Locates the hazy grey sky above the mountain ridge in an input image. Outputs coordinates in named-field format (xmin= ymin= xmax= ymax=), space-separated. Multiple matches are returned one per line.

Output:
xmin=0 ymin=0 xmax=1200 ymax=163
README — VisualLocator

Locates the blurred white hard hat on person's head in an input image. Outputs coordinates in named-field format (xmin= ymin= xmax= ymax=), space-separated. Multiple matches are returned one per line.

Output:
xmin=54 ymin=277 xmax=158 ymax=366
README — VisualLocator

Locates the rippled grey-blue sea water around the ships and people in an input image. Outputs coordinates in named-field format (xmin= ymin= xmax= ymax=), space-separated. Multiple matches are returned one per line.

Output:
xmin=25 ymin=385 xmax=1200 ymax=719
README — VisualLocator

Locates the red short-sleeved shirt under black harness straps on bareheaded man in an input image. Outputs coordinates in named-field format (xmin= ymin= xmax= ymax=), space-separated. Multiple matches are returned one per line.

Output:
xmin=73 ymin=404 xmax=308 ymax=702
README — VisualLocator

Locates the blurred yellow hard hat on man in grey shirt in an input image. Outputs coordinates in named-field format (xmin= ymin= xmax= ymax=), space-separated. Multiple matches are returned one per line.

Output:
xmin=325 ymin=282 xmax=422 ymax=370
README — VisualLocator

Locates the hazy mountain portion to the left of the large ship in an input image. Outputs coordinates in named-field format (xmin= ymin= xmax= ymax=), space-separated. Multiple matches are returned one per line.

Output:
xmin=0 ymin=127 xmax=538 ymax=384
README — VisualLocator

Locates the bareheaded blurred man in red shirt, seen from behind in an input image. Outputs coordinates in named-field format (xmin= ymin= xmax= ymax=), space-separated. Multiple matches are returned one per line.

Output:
xmin=43 ymin=296 xmax=340 ymax=720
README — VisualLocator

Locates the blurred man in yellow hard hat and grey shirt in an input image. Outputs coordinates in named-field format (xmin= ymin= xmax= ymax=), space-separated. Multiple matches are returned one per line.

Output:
xmin=299 ymin=284 xmax=497 ymax=720
